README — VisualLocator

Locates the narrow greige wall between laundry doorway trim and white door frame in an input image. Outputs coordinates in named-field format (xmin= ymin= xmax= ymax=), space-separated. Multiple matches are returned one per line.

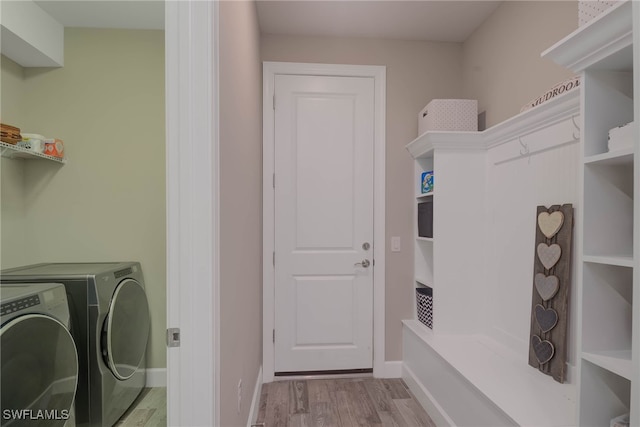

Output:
xmin=219 ymin=1 xmax=262 ymax=427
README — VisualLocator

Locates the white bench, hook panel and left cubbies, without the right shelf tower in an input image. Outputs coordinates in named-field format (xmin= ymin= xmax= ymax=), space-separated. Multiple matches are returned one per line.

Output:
xmin=403 ymin=90 xmax=580 ymax=426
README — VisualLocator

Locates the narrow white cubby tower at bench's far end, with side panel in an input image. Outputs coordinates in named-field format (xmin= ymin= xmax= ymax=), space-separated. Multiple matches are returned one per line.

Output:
xmin=407 ymin=132 xmax=486 ymax=333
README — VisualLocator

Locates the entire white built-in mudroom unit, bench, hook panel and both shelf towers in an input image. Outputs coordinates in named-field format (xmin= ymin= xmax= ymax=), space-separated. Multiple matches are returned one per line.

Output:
xmin=403 ymin=1 xmax=640 ymax=426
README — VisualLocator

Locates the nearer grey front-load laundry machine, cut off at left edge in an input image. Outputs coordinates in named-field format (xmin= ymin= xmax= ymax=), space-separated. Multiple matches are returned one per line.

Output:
xmin=0 ymin=283 xmax=78 ymax=427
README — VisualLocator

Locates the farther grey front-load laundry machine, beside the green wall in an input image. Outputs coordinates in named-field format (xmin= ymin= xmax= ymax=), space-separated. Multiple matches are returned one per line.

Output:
xmin=0 ymin=262 xmax=151 ymax=427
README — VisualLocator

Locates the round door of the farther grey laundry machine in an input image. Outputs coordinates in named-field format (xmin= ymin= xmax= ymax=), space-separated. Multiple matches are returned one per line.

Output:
xmin=102 ymin=279 xmax=151 ymax=380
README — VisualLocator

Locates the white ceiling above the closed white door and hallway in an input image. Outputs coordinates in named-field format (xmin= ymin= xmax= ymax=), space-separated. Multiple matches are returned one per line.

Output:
xmin=257 ymin=0 xmax=502 ymax=42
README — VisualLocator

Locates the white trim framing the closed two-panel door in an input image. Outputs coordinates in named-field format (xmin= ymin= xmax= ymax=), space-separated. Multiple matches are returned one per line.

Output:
xmin=262 ymin=62 xmax=386 ymax=383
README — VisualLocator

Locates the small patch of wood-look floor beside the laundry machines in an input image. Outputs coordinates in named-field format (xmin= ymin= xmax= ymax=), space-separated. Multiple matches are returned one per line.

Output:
xmin=115 ymin=387 xmax=167 ymax=427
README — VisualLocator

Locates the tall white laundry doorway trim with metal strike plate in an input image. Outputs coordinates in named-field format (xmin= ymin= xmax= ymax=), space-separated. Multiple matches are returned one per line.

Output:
xmin=165 ymin=1 xmax=220 ymax=426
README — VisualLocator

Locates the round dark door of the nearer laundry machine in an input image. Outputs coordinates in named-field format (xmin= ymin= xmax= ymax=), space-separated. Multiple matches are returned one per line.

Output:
xmin=0 ymin=314 xmax=78 ymax=426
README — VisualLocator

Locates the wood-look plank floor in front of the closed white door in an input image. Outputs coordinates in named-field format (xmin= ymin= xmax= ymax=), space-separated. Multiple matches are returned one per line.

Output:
xmin=254 ymin=378 xmax=435 ymax=427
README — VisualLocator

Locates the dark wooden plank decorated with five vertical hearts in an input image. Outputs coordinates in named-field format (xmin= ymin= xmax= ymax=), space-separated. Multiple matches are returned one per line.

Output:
xmin=529 ymin=204 xmax=573 ymax=383
